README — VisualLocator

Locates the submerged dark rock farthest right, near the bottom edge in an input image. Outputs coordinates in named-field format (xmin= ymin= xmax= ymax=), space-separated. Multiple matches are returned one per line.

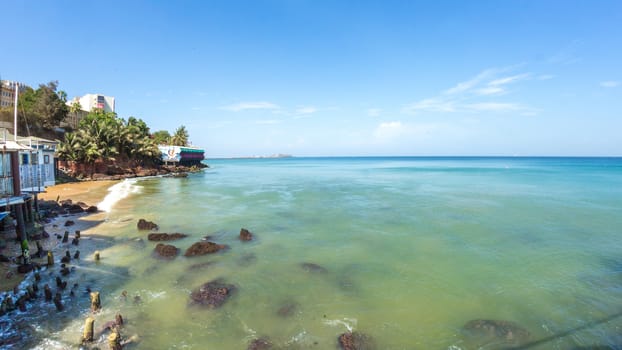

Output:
xmin=462 ymin=320 xmax=529 ymax=344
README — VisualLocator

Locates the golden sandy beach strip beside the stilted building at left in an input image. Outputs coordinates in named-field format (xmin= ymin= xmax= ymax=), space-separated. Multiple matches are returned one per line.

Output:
xmin=0 ymin=181 xmax=118 ymax=292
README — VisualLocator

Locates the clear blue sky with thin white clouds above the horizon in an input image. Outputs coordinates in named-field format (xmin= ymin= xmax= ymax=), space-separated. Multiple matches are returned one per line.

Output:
xmin=0 ymin=0 xmax=622 ymax=157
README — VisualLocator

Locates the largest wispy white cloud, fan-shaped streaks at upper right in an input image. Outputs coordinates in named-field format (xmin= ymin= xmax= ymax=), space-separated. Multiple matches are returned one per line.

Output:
xmin=402 ymin=66 xmax=536 ymax=114
